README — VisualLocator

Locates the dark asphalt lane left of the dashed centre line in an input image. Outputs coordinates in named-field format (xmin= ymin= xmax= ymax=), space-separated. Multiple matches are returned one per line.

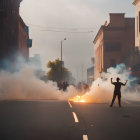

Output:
xmin=0 ymin=101 xmax=82 ymax=140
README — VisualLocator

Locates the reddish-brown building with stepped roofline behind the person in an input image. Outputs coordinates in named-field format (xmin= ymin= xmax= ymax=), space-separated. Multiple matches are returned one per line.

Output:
xmin=94 ymin=13 xmax=135 ymax=79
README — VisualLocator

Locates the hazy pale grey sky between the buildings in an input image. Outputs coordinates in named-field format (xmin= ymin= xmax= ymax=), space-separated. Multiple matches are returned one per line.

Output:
xmin=20 ymin=0 xmax=135 ymax=81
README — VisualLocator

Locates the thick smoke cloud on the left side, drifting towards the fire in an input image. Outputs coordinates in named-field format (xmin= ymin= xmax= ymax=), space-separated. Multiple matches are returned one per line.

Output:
xmin=0 ymin=57 xmax=76 ymax=100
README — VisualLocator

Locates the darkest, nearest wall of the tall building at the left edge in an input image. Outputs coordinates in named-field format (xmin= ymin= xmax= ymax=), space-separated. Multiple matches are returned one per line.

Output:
xmin=0 ymin=0 xmax=19 ymax=67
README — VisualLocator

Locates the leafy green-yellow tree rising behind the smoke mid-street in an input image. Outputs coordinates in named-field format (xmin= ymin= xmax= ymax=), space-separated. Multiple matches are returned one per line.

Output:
xmin=47 ymin=59 xmax=69 ymax=82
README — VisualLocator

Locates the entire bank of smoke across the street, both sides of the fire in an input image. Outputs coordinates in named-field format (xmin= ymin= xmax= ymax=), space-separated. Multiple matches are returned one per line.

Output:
xmin=0 ymin=60 xmax=140 ymax=103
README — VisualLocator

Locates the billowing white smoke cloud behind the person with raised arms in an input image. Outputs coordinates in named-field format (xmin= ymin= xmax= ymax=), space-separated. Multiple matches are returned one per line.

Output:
xmin=79 ymin=64 xmax=140 ymax=103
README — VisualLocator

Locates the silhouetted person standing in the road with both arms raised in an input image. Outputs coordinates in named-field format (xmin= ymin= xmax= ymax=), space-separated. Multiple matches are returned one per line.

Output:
xmin=110 ymin=78 xmax=127 ymax=107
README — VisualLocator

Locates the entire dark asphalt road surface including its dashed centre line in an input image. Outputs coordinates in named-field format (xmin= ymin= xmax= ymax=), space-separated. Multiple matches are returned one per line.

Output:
xmin=0 ymin=101 xmax=140 ymax=140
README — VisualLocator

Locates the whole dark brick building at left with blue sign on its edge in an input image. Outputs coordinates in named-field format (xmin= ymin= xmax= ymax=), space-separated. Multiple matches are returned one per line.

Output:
xmin=0 ymin=0 xmax=32 ymax=68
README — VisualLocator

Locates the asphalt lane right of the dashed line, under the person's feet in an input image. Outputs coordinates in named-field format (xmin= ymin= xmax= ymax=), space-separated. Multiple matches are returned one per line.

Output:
xmin=72 ymin=102 xmax=140 ymax=140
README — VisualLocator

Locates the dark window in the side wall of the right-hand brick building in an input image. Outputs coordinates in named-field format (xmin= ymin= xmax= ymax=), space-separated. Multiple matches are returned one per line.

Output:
xmin=105 ymin=42 xmax=122 ymax=52
